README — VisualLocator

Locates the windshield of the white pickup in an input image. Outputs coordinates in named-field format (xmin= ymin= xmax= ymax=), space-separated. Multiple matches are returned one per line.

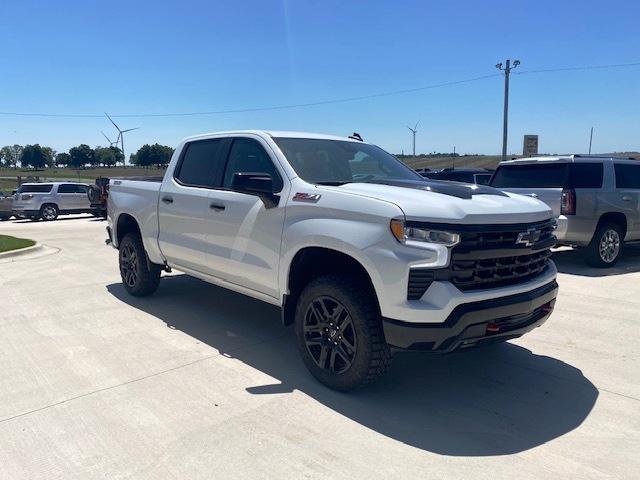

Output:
xmin=274 ymin=138 xmax=424 ymax=185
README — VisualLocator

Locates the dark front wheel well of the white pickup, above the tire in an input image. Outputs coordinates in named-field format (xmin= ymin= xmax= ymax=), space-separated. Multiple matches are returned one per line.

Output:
xmin=282 ymin=246 xmax=380 ymax=325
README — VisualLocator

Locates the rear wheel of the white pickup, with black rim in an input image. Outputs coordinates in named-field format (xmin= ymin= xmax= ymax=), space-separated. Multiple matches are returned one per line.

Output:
xmin=118 ymin=233 xmax=162 ymax=297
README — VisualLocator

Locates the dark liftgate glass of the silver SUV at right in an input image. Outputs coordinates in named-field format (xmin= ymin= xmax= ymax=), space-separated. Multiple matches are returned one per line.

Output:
xmin=491 ymin=163 xmax=567 ymax=188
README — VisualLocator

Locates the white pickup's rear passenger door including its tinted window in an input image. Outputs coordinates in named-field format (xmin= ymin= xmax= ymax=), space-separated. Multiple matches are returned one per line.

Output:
xmin=158 ymin=138 xmax=229 ymax=274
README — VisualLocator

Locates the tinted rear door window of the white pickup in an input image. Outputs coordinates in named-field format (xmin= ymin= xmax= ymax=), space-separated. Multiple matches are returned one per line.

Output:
xmin=173 ymin=138 xmax=225 ymax=187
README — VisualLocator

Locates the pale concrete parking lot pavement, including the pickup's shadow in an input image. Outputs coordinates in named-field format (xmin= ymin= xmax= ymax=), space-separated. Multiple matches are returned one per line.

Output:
xmin=0 ymin=216 xmax=640 ymax=480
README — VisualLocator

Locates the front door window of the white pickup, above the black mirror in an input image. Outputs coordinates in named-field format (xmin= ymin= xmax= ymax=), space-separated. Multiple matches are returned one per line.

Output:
xmin=222 ymin=138 xmax=282 ymax=189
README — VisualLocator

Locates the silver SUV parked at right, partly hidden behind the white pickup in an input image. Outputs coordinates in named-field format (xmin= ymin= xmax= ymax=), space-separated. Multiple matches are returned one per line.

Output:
xmin=491 ymin=155 xmax=640 ymax=267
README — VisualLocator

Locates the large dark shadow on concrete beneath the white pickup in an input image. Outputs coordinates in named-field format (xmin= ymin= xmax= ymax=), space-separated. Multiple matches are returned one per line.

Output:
xmin=107 ymin=275 xmax=598 ymax=456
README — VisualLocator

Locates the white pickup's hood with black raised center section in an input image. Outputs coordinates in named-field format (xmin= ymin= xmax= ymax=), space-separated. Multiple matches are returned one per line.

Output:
xmin=323 ymin=180 xmax=552 ymax=224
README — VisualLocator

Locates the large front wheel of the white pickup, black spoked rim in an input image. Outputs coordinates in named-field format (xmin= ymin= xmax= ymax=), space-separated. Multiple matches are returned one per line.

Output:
xmin=295 ymin=275 xmax=392 ymax=391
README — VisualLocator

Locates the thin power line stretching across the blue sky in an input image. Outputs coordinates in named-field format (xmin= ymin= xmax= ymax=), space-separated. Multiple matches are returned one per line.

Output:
xmin=0 ymin=62 xmax=640 ymax=118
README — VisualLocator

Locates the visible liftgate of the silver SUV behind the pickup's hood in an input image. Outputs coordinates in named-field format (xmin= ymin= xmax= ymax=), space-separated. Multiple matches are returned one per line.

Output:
xmin=491 ymin=162 xmax=568 ymax=217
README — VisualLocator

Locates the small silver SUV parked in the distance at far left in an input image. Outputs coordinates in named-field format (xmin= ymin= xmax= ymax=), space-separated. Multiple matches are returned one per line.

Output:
xmin=13 ymin=182 xmax=93 ymax=221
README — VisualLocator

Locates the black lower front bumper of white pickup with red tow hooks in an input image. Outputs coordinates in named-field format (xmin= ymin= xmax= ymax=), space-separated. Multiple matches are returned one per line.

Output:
xmin=383 ymin=280 xmax=558 ymax=353
